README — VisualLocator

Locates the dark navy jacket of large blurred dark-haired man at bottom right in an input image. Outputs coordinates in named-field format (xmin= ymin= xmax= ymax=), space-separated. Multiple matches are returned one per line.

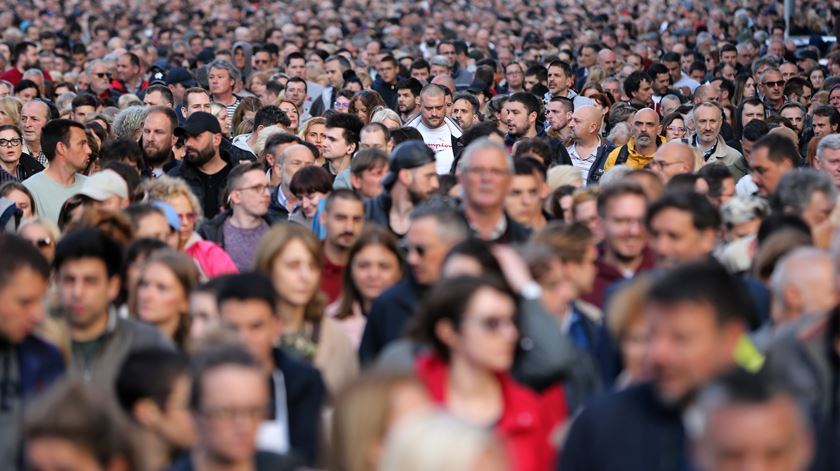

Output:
xmin=558 ymin=383 xmax=688 ymax=471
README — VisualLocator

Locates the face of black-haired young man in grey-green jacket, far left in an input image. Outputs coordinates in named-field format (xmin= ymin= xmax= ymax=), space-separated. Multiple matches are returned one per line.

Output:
xmin=58 ymin=258 xmax=120 ymax=329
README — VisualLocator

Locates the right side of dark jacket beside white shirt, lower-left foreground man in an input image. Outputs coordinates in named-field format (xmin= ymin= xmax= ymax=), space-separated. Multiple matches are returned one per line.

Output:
xmin=272 ymin=348 xmax=327 ymax=466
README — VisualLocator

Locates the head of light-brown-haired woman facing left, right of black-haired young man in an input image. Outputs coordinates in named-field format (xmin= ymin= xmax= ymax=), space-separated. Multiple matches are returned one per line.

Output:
xmin=133 ymin=250 xmax=199 ymax=348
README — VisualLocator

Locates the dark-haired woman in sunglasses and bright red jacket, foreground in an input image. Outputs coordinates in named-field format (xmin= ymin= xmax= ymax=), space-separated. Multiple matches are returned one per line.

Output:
xmin=411 ymin=276 xmax=556 ymax=470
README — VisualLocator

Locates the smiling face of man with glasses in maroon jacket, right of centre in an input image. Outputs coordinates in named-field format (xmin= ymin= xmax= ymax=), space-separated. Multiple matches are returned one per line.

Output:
xmin=603 ymin=194 xmax=647 ymax=261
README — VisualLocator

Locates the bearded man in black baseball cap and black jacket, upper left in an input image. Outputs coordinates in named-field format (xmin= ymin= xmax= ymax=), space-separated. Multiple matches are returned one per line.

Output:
xmin=169 ymin=111 xmax=230 ymax=219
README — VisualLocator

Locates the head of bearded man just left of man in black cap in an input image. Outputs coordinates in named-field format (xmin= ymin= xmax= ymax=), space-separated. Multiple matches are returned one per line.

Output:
xmin=140 ymin=106 xmax=178 ymax=178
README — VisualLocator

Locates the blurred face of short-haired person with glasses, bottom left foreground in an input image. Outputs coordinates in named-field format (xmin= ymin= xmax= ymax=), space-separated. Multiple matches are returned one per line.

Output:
xmin=195 ymin=365 xmax=269 ymax=462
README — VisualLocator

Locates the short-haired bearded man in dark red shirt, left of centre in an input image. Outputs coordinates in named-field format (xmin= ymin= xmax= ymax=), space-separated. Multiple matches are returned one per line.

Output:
xmin=321 ymin=188 xmax=365 ymax=303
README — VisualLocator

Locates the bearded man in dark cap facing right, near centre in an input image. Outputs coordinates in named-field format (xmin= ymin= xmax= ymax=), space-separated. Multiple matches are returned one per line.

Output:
xmin=365 ymin=141 xmax=438 ymax=237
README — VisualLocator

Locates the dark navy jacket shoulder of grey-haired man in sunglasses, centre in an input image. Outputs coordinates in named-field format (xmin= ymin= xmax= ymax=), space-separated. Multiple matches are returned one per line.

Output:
xmin=359 ymin=273 xmax=423 ymax=365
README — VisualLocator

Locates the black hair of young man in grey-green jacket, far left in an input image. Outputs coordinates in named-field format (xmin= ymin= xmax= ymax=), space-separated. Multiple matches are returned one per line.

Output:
xmin=53 ymin=227 xmax=123 ymax=278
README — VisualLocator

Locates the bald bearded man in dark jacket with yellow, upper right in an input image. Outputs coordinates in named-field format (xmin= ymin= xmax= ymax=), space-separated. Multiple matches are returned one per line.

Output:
xmin=590 ymin=108 xmax=665 ymax=180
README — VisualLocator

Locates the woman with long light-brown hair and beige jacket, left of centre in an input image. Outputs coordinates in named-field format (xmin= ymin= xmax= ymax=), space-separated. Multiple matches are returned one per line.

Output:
xmin=254 ymin=223 xmax=359 ymax=391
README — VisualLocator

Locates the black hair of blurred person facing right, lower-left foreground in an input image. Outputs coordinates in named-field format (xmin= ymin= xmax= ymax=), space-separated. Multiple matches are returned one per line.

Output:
xmin=115 ymin=348 xmax=189 ymax=416
